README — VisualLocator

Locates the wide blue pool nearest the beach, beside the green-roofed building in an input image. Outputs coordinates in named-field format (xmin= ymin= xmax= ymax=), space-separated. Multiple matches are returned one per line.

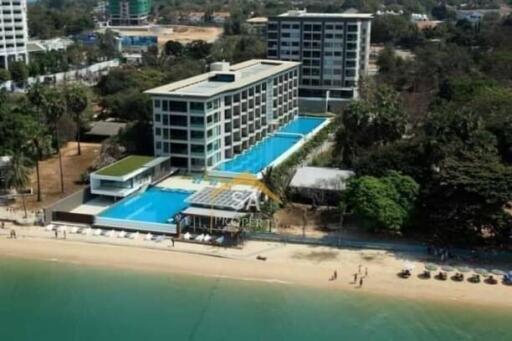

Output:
xmin=99 ymin=187 xmax=191 ymax=224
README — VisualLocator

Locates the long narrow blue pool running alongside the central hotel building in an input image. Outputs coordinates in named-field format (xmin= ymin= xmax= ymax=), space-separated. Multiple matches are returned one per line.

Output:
xmin=216 ymin=116 xmax=325 ymax=174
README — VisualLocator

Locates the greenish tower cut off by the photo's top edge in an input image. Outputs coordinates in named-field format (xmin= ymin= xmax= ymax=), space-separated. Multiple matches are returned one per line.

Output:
xmin=108 ymin=0 xmax=151 ymax=26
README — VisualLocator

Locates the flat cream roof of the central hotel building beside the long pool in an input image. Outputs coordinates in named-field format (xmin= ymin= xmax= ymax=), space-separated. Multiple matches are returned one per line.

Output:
xmin=145 ymin=59 xmax=300 ymax=98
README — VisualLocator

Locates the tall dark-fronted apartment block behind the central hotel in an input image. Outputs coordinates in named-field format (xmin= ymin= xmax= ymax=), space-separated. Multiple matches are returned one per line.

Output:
xmin=267 ymin=10 xmax=372 ymax=107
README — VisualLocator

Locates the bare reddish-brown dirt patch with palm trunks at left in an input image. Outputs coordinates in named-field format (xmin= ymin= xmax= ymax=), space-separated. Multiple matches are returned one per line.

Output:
xmin=16 ymin=142 xmax=101 ymax=210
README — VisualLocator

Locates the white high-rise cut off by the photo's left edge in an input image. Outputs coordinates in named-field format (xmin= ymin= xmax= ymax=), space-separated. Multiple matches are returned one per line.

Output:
xmin=0 ymin=0 xmax=28 ymax=69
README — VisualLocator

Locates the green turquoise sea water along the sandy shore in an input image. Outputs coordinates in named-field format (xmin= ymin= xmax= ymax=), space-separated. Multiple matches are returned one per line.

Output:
xmin=0 ymin=259 xmax=512 ymax=341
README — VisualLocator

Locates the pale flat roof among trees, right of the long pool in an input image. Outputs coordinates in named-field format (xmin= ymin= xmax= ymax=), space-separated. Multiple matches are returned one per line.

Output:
xmin=290 ymin=167 xmax=355 ymax=191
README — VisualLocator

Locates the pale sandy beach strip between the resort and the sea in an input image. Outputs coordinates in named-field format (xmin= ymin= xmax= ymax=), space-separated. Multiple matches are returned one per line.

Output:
xmin=0 ymin=227 xmax=512 ymax=308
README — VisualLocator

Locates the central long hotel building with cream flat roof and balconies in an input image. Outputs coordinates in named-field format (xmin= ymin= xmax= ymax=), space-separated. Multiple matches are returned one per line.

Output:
xmin=146 ymin=60 xmax=300 ymax=172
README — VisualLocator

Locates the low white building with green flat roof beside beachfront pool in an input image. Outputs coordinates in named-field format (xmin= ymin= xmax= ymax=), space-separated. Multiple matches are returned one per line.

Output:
xmin=90 ymin=155 xmax=172 ymax=198
